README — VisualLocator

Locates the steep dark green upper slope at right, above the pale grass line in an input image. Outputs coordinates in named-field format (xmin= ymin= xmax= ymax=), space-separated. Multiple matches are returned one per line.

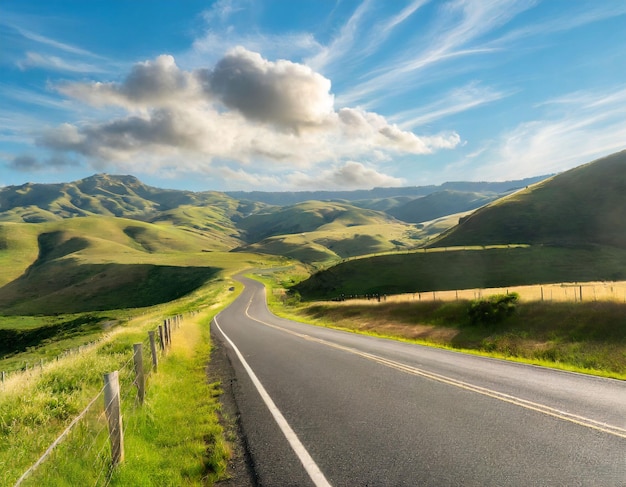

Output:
xmin=429 ymin=151 xmax=626 ymax=252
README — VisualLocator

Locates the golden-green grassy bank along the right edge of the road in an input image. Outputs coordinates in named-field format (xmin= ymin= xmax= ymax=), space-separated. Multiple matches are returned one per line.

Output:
xmin=261 ymin=277 xmax=626 ymax=380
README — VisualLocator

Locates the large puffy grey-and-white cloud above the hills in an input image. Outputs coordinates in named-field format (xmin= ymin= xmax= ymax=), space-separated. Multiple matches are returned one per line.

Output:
xmin=29 ymin=47 xmax=460 ymax=186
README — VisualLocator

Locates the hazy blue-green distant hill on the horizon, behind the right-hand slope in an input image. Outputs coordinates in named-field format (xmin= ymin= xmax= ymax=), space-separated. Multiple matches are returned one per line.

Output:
xmin=387 ymin=189 xmax=500 ymax=223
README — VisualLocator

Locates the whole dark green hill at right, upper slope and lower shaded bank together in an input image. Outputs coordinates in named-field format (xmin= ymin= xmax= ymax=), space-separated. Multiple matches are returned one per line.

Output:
xmin=295 ymin=151 xmax=626 ymax=299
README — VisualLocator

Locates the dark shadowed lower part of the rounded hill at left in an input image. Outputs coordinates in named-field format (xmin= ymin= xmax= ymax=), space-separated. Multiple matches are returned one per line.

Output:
xmin=0 ymin=259 xmax=219 ymax=315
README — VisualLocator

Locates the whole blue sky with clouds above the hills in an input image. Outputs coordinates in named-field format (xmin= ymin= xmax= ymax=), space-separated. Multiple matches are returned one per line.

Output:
xmin=0 ymin=0 xmax=626 ymax=191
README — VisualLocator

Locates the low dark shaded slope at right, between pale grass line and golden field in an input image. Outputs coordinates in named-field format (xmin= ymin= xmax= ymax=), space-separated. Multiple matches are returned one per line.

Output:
xmin=294 ymin=246 xmax=626 ymax=300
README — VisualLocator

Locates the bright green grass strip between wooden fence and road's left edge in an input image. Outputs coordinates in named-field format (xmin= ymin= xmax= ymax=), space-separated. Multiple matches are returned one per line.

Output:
xmin=111 ymin=316 xmax=230 ymax=486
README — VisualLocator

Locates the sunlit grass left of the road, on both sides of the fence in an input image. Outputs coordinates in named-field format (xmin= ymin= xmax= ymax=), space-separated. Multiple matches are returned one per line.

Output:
xmin=0 ymin=281 xmax=235 ymax=486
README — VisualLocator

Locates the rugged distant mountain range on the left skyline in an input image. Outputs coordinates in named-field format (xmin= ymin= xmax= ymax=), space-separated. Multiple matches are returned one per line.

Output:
xmin=0 ymin=174 xmax=266 ymax=250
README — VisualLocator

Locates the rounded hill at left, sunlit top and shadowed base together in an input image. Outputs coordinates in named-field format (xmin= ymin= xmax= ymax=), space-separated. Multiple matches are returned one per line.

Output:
xmin=0 ymin=217 xmax=270 ymax=315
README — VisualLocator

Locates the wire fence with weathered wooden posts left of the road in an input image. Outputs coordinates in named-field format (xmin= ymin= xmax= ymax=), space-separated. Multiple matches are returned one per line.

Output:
xmin=15 ymin=315 xmax=183 ymax=487
